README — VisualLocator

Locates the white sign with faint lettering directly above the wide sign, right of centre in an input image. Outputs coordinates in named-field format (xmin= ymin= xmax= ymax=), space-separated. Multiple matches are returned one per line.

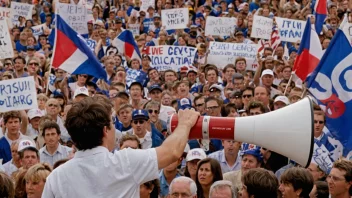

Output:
xmin=205 ymin=16 xmax=237 ymax=36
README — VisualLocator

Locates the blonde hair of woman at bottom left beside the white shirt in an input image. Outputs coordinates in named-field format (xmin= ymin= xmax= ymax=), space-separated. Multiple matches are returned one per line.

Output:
xmin=24 ymin=163 xmax=52 ymax=182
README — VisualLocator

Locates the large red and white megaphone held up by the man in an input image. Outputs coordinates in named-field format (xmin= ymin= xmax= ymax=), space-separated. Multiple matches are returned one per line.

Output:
xmin=168 ymin=97 xmax=314 ymax=167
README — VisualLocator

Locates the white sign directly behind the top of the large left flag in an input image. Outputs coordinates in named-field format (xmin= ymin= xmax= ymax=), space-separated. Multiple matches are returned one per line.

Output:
xmin=58 ymin=3 xmax=88 ymax=34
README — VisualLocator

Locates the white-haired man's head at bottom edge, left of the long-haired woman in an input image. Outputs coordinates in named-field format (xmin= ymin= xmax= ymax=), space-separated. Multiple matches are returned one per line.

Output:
xmin=169 ymin=176 xmax=197 ymax=198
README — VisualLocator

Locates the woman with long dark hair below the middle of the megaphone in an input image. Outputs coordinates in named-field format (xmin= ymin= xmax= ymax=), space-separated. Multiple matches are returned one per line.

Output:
xmin=196 ymin=158 xmax=223 ymax=198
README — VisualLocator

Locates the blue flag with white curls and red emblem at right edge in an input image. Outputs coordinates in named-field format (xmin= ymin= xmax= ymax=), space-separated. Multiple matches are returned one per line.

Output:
xmin=307 ymin=19 xmax=352 ymax=156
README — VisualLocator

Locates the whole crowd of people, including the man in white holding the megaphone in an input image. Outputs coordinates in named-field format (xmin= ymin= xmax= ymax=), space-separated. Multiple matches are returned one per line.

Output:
xmin=0 ymin=0 xmax=352 ymax=198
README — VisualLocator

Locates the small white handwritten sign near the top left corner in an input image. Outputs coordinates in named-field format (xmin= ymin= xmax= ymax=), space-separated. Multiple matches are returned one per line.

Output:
xmin=11 ymin=1 xmax=33 ymax=25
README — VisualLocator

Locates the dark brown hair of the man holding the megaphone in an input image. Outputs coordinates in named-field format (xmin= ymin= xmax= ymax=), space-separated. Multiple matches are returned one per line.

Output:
xmin=65 ymin=95 xmax=112 ymax=150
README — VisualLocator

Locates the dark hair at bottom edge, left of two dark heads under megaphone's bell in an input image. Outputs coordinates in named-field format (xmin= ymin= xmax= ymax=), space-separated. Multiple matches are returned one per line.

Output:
xmin=242 ymin=168 xmax=279 ymax=198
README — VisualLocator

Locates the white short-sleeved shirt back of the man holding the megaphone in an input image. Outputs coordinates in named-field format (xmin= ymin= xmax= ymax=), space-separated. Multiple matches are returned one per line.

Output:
xmin=42 ymin=147 xmax=159 ymax=198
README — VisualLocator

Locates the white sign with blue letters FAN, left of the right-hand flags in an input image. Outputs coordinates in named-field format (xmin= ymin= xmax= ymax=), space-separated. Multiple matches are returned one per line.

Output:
xmin=275 ymin=17 xmax=306 ymax=43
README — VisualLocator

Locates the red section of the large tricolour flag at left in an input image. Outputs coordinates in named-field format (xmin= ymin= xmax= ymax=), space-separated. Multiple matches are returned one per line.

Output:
xmin=52 ymin=30 xmax=77 ymax=68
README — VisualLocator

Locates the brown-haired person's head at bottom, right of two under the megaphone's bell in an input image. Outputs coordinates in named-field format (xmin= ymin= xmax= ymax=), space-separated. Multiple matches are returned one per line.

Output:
xmin=279 ymin=167 xmax=313 ymax=198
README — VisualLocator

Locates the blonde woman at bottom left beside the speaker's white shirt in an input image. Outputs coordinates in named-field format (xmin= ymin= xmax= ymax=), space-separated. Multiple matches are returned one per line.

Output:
xmin=24 ymin=163 xmax=51 ymax=198
